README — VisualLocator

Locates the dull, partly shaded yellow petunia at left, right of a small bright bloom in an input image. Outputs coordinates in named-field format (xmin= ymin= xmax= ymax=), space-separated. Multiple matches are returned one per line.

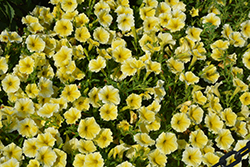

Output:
xmin=38 ymin=77 xmax=54 ymax=98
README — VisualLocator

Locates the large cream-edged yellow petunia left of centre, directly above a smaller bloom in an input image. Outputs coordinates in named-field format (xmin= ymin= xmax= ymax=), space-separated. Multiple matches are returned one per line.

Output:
xmin=98 ymin=85 xmax=120 ymax=105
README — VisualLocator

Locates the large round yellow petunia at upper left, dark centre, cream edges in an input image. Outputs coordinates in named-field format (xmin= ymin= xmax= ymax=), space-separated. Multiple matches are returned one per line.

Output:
xmin=25 ymin=35 xmax=45 ymax=52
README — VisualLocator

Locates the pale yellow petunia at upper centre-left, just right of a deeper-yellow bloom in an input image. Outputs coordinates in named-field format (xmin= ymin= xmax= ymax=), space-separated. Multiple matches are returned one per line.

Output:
xmin=93 ymin=27 xmax=110 ymax=44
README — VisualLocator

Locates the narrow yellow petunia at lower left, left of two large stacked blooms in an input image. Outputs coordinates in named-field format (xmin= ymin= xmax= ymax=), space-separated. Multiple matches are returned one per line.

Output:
xmin=23 ymin=138 xmax=38 ymax=158
